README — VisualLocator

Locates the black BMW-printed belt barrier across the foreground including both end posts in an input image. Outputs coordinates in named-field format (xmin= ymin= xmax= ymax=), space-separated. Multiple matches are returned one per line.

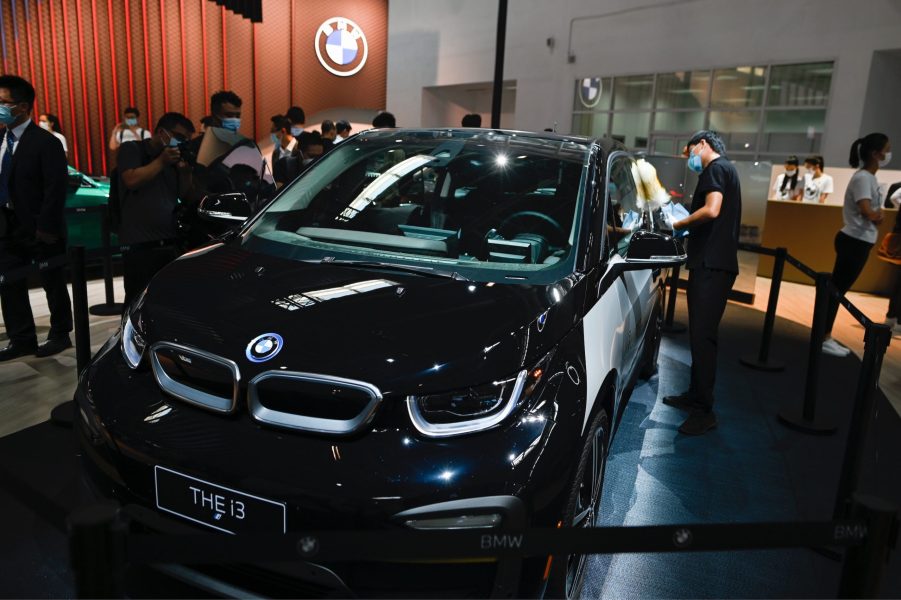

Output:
xmin=61 ymin=496 xmax=898 ymax=597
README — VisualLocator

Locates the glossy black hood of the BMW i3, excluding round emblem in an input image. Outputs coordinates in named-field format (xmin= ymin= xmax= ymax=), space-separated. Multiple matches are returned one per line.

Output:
xmin=140 ymin=245 xmax=577 ymax=395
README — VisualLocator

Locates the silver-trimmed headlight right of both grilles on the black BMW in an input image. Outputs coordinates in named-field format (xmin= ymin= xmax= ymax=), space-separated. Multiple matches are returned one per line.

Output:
xmin=407 ymin=369 xmax=541 ymax=437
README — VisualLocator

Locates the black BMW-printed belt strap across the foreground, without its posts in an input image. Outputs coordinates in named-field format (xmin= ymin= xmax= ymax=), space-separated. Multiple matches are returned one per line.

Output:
xmin=119 ymin=519 xmax=866 ymax=564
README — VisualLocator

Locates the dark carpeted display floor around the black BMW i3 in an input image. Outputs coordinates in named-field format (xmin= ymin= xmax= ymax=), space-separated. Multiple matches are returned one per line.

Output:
xmin=0 ymin=296 xmax=901 ymax=598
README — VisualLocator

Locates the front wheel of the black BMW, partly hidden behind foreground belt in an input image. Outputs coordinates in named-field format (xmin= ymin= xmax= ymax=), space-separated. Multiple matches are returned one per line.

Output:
xmin=545 ymin=409 xmax=610 ymax=598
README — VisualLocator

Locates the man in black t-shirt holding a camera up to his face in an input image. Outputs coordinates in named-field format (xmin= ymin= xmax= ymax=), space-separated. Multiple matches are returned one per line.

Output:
xmin=118 ymin=112 xmax=194 ymax=306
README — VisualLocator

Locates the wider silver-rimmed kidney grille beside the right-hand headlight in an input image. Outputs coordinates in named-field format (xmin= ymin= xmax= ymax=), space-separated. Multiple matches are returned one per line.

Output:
xmin=248 ymin=371 xmax=382 ymax=435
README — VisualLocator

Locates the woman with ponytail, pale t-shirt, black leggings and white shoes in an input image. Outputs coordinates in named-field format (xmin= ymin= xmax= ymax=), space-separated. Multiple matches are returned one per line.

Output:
xmin=823 ymin=133 xmax=892 ymax=356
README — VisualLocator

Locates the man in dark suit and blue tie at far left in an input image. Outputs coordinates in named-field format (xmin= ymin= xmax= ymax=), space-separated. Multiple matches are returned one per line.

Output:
xmin=0 ymin=75 xmax=72 ymax=362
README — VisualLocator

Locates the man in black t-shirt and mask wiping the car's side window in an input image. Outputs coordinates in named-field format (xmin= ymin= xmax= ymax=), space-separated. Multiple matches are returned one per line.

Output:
xmin=663 ymin=131 xmax=741 ymax=435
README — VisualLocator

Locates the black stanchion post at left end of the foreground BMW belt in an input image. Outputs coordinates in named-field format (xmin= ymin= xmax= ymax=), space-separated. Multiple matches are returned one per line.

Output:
xmin=69 ymin=504 xmax=127 ymax=598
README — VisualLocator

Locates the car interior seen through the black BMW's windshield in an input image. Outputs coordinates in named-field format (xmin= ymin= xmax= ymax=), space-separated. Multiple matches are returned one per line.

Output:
xmin=277 ymin=145 xmax=581 ymax=265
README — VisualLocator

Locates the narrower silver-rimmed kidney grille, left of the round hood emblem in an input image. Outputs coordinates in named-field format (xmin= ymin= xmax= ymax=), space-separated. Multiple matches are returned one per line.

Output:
xmin=151 ymin=342 xmax=240 ymax=413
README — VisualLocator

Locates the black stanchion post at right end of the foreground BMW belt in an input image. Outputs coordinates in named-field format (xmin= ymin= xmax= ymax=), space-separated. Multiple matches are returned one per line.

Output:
xmin=838 ymin=494 xmax=898 ymax=598
